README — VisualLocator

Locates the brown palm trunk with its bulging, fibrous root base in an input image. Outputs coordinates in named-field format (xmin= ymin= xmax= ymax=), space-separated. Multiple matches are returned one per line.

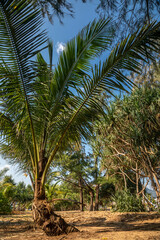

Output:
xmin=32 ymin=155 xmax=78 ymax=236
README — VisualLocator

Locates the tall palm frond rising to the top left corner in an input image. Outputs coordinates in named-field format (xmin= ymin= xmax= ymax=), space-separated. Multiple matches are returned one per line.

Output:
xmin=0 ymin=0 xmax=46 ymax=174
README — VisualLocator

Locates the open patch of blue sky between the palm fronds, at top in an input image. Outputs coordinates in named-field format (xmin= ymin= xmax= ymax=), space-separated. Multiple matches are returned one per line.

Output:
xmin=44 ymin=0 xmax=99 ymax=64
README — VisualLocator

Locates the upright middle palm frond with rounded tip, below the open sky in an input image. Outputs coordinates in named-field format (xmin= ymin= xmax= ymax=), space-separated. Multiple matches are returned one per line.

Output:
xmin=54 ymin=19 xmax=113 ymax=104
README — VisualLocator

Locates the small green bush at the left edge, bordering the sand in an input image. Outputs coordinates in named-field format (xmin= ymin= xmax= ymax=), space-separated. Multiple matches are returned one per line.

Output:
xmin=0 ymin=190 xmax=12 ymax=214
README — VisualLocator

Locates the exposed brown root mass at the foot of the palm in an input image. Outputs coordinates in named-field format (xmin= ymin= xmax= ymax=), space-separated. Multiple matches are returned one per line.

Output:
xmin=32 ymin=200 xmax=79 ymax=236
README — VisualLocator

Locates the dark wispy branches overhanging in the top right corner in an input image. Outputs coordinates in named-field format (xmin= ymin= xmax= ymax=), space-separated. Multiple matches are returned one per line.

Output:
xmin=97 ymin=0 xmax=160 ymax=38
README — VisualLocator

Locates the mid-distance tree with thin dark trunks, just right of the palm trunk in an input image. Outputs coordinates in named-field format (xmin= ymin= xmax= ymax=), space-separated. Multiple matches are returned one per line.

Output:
xmin=53 ymin=144 xmax=94 ymax=211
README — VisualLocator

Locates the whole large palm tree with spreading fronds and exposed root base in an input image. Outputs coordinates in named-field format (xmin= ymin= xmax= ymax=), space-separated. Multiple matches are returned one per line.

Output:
xmin=0 ymin=0 xmax=160 ymax=235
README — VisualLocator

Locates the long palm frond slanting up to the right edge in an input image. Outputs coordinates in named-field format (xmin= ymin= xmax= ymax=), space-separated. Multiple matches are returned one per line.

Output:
xmin=41 ymin=23 xmax=160 ymax=184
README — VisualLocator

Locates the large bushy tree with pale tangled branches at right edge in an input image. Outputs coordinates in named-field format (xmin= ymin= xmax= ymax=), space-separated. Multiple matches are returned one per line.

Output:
xmin=94 ymin=82 xmax=160 ymax=202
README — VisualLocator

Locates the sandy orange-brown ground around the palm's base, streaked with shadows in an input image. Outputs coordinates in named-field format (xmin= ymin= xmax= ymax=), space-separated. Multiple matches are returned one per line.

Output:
xmin=0 ymin=211 xmax=160 ymax=240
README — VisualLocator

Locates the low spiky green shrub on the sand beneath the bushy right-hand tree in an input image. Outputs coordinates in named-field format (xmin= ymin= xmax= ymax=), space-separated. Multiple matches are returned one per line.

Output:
xmin=113 ymin=191 xmax=145 ymax=212
